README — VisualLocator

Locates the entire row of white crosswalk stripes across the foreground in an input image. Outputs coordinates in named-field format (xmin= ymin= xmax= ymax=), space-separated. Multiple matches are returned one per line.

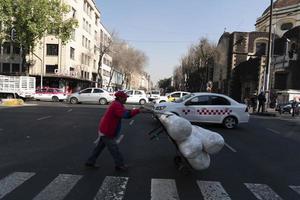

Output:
xmin=0 ymin=172 xmax=300 ymax=200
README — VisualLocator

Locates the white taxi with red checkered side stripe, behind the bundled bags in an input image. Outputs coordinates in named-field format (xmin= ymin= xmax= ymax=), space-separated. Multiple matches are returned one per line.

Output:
xmin=154 ymin=93 xmax=249 ymax=129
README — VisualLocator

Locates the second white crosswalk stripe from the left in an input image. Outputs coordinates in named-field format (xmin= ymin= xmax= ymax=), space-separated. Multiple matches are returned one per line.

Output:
xmin=33 ymin=174 xmax=82 ymax=200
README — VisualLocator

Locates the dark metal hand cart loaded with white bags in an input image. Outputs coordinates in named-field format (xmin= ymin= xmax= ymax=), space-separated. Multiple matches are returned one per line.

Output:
xmin=148 ymin=111 xmax=193 ymax=175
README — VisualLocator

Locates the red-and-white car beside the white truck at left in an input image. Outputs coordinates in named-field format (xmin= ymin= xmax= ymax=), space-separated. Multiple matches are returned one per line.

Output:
xmin=34 ymin=87 xmax=67 ymax=102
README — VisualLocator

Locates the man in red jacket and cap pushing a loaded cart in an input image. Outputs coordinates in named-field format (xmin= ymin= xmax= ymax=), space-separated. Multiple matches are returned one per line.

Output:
xmin=85 ymin=91 xmax=140 ymax=171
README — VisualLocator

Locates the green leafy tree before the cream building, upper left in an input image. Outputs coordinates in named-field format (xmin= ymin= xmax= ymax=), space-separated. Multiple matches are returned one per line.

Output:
xmin=0 ymin=0 xmax=78 ymax=73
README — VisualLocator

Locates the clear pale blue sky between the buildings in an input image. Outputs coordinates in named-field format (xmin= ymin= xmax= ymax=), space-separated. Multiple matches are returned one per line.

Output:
xmin=96 ymin=0 xmax=270 ymax=84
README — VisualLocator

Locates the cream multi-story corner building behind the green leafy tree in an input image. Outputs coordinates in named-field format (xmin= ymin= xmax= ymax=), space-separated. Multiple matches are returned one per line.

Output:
xmin=0 ymin=0 xmax=112 ymax=91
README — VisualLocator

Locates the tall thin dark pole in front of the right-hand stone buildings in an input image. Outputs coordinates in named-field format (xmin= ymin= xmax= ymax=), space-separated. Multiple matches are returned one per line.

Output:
xmin=264 ymin=0 xmax=273 ymax=107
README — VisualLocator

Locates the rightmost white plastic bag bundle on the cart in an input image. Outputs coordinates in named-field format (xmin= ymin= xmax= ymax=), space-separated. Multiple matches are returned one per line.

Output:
xmin=195 ymin=126 xmax=225 ymax=154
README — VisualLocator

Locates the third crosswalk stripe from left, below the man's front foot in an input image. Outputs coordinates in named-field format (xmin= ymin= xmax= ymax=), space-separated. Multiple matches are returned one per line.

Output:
xmin=94 ymin=176 xmax=129 ymax=200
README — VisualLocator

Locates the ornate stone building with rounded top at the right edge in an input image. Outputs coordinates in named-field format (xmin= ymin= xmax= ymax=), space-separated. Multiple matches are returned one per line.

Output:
xmin=255 ymin=0 xmax=300 ymax=90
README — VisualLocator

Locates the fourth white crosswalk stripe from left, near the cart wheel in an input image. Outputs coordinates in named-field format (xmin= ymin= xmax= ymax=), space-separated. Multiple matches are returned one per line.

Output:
xmin=151 ymin=179 xmax=179 ymax=200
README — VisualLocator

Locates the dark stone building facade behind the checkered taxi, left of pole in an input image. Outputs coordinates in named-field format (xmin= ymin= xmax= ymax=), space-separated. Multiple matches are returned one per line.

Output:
xmin=213 ymin=32 xmax=268 ymax=101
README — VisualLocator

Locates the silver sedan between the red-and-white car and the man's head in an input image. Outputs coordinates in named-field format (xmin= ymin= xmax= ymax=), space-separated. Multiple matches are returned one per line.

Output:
xmin=68 ymin=88 xmax=114 ymax=105
